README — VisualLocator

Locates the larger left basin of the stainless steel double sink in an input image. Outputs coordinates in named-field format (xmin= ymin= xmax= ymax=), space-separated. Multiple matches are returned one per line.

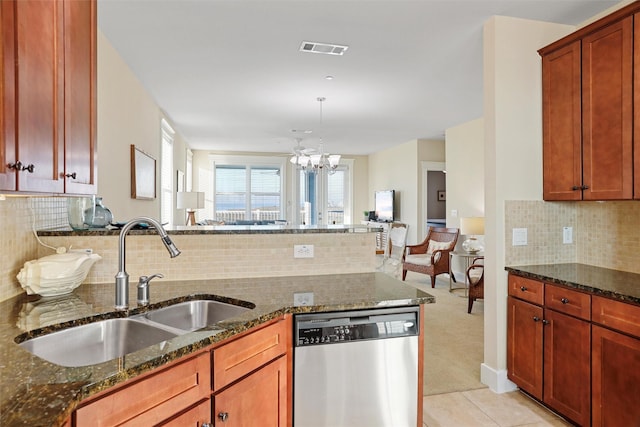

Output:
xmin=19 ymin=318 xmax=177 ymax=367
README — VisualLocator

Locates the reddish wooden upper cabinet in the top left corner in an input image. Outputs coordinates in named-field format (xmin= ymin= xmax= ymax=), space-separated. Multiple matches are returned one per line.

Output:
xmin=0 ymin=0 xmax=97 ymax=194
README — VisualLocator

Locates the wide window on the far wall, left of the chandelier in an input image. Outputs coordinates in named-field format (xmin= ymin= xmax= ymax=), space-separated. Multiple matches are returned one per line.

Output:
xmin=213 ymin=156 xmax=286 ymax=223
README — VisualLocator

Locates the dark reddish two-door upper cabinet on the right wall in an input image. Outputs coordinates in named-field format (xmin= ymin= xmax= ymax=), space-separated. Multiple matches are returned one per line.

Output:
xmin=539 ymin=8 xmax=640 ymax=200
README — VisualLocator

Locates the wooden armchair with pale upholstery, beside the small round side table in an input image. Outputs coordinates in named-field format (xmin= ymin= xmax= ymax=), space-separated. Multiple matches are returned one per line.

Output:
xmin=402 ymin=227 xmax=460 ymax=288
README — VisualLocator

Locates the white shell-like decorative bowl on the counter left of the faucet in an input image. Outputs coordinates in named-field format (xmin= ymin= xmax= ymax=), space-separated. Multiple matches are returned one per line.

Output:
xmin=17 ymin=252 xmax=102 ymax=296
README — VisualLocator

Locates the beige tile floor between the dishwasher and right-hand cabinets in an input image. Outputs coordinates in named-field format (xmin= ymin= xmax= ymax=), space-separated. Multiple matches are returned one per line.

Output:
xmin=423 ymin=388 xmax=571 ymax=427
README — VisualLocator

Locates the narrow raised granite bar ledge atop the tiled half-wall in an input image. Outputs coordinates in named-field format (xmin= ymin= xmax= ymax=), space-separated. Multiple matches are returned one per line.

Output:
xmin=38 ymin=224 xmax=382 ymax=236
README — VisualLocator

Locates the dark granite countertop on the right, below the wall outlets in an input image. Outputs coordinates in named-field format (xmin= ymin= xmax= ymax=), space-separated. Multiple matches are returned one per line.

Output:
xmin=505 ymin=263 xmax=640 ymax=304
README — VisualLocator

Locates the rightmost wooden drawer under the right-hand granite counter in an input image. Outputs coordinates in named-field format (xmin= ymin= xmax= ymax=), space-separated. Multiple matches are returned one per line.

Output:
xmin=591 ymin=295 xmax=640 ymax=337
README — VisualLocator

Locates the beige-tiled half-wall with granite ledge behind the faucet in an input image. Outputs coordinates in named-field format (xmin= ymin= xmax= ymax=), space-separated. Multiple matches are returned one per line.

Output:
xmin=38 ymin=225 xmax=380 ymax=283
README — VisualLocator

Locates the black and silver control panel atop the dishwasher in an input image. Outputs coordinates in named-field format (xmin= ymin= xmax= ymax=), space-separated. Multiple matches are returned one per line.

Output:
xmin=294 ymin=310 xmax=419 ymax=347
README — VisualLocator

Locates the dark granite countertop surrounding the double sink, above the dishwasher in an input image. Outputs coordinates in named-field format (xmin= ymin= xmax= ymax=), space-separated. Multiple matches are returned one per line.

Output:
xmin=0 ymin=273 xmax=435 ymax=427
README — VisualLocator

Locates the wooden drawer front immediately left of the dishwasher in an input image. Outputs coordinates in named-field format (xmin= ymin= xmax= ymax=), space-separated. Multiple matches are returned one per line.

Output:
xmin=213 ymin=320 xmax=291 ymax=391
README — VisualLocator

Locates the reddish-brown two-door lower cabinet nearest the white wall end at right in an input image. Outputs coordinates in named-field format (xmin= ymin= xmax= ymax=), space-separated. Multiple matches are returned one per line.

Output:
xmin=507 ymin=276 xmax=591 ymax=426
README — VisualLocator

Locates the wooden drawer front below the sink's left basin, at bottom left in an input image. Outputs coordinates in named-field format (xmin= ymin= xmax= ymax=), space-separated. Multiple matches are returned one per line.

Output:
xmin=76 ymin=353 xmax=211 ymax=427
